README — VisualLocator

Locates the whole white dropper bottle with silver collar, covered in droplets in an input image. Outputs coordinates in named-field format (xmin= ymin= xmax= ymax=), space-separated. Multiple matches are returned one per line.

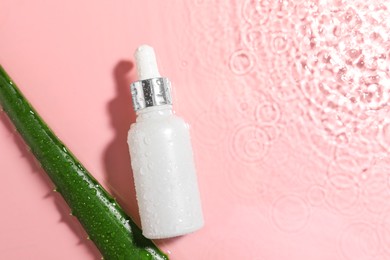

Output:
xmin=128 ymin=45 xmax=203 ymax=239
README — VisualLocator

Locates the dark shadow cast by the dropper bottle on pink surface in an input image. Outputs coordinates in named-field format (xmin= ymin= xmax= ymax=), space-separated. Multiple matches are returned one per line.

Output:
xmin=103 ymin=61 xmax=141 ymax=226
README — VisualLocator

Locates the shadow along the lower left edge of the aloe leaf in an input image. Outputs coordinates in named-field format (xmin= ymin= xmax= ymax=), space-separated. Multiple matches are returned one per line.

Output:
xmin=0 ymin=113 xmax=101 ymax=259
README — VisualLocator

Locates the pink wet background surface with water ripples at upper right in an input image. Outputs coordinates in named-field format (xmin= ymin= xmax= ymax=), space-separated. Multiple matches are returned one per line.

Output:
xmin=0 ymin=0 xmax=390 ymax=260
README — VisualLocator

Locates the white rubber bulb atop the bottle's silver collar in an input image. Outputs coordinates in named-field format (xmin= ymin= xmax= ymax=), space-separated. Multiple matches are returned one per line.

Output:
xmin=134 ymin=45 xmax=161 ymax=80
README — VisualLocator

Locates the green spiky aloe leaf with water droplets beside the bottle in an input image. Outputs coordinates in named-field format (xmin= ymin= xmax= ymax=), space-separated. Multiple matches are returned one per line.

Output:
xmin=0 ymin=66 xmax=168 ymax=260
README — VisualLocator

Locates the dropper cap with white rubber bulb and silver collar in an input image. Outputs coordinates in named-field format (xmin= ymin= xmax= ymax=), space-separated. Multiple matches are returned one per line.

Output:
xmin=130 ymin=45 xmax=172 ymax=111
